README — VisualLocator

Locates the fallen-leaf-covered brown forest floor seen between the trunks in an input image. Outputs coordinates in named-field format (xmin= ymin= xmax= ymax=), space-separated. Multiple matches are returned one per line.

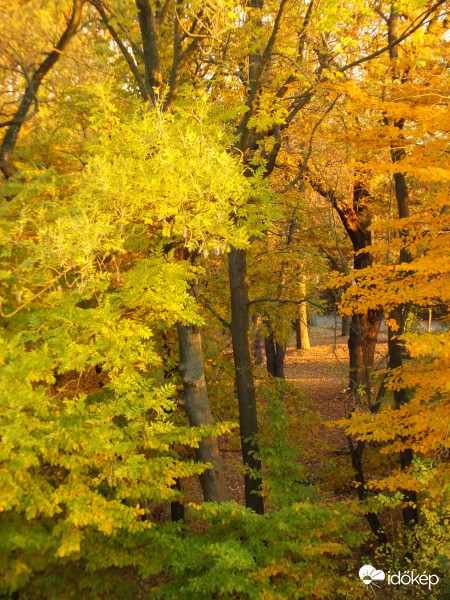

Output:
xmin=216 ymin=315 xmax=387 ymax=504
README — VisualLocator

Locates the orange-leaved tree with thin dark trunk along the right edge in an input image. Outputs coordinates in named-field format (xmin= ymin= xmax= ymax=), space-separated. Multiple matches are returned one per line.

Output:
xmin=336 ymin=2 xmax=446 ymax=558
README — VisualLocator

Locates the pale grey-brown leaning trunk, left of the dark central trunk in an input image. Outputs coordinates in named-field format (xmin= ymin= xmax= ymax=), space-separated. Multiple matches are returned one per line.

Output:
xmin=177 ymin=323 xmax=228 ymax=502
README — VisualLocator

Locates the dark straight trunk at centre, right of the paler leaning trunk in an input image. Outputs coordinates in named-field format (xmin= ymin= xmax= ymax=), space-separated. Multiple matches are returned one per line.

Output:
xmin=228 ymin=248 xmax=264 ymax=515
